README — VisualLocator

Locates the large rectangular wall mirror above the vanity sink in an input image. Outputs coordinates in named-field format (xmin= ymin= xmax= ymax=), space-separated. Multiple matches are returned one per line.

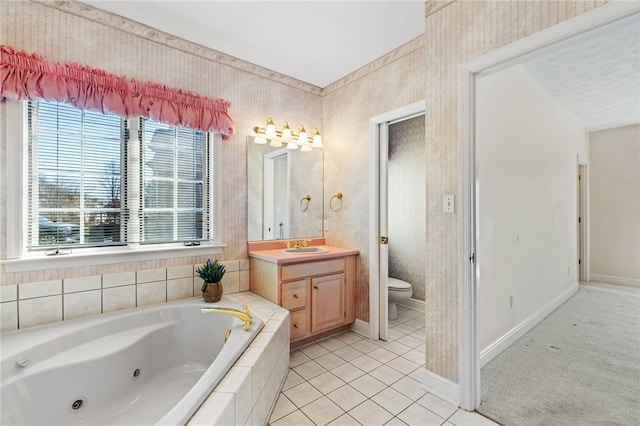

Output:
xmin=247 ymin=136 xmax=324 ymax=241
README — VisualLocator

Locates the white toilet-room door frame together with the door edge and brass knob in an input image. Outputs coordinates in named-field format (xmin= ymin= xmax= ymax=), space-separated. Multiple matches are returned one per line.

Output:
xmin=369 ymin=100 xmax=425 ymax=340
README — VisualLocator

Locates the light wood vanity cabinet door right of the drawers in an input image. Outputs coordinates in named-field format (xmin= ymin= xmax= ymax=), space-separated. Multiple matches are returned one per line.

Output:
xmin=311 ymin=274 xmax=346 ymax=333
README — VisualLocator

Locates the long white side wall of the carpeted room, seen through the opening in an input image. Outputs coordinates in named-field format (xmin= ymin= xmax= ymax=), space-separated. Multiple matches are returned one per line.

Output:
xmin=476 ymin=66 xmax=588 ymax=362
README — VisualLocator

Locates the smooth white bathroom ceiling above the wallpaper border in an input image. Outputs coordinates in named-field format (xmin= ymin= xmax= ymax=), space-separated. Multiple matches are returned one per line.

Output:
xmin=84 ymin=0 xmax=425 ymax=87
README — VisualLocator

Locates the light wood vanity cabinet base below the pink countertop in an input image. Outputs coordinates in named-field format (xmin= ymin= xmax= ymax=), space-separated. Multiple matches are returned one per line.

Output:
xmin=250 ymin=255 xmax=357 ymax=342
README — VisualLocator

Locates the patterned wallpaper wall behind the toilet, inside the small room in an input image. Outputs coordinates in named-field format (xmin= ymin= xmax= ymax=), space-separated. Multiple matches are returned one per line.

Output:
xmin=387 ymin=115 xmax=426 ymax=301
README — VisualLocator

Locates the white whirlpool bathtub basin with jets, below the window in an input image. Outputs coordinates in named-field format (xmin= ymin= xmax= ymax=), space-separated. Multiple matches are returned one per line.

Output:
xmin=0 ymin=299 xmax=263 ymax=425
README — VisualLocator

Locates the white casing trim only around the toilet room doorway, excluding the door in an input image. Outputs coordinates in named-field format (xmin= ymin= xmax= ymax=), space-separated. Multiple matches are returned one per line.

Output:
xmin=369 ymin=99 xmax=426 ymax=340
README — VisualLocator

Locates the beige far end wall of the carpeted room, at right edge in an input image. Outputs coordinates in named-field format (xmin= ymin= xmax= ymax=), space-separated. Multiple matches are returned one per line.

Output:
xmin=589 ymin=125 xmax=640 ymax=285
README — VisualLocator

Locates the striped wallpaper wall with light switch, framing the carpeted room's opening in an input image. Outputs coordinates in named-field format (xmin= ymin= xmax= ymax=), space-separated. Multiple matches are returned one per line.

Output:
xmin=425 ymin=0 xmax=607 ymax=382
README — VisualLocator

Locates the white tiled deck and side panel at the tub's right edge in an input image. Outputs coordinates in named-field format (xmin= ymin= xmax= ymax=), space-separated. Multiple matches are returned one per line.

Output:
xmin=187 ymin=291 xmax=289 ymax=426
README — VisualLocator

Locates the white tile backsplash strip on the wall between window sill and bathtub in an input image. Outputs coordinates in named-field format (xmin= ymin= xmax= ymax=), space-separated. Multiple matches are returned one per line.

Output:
xmin=0 ymin=259 xmax=249 ymax=331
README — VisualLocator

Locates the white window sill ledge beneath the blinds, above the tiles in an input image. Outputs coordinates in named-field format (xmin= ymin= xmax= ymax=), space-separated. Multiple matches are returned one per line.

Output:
xmin=0 ymin=244 xmax=226 ymax=273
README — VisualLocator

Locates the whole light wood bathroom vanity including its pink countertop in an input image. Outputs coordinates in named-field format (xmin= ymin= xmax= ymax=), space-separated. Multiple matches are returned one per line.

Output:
xmin=249 ymin=238 xmax=358 ymax=343
